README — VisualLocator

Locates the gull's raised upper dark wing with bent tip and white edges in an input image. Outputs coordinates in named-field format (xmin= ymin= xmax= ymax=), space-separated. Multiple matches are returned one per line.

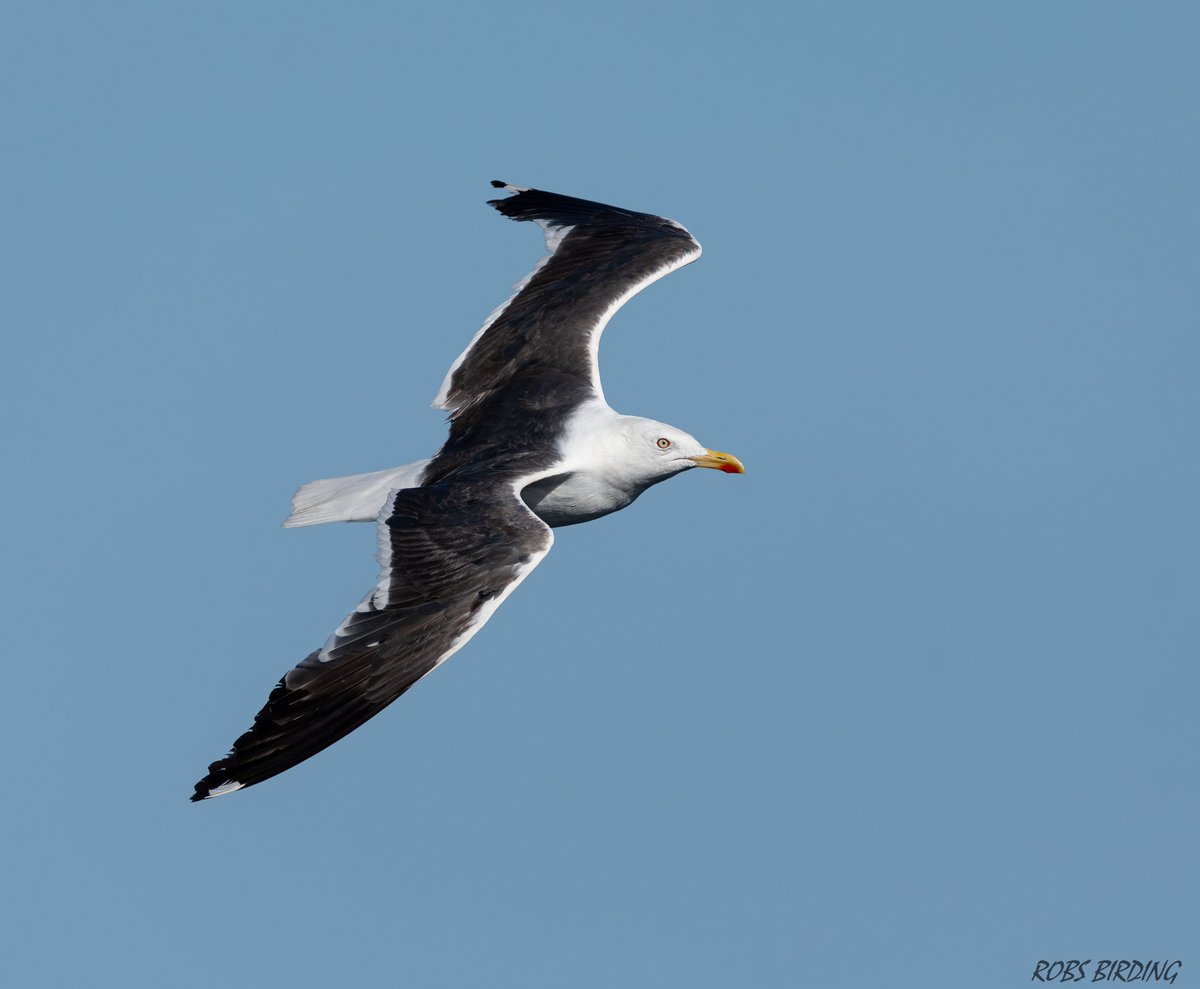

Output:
xmin=433 ymin=181 xmax=700 ymax=412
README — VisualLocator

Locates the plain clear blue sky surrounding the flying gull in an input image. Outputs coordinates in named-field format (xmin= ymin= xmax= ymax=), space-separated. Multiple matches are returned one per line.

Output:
xmin=0 ymin=0 xmax=1200 ymax=989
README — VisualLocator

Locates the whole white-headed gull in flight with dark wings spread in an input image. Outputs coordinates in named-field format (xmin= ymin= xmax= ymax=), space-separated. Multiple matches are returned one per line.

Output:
xmin=192 ymin=182 xmax=743 ymax=801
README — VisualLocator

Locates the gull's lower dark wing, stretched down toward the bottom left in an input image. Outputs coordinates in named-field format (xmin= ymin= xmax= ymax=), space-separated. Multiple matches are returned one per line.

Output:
xmin=192 ymin=476 xmax=553 ymax=801
